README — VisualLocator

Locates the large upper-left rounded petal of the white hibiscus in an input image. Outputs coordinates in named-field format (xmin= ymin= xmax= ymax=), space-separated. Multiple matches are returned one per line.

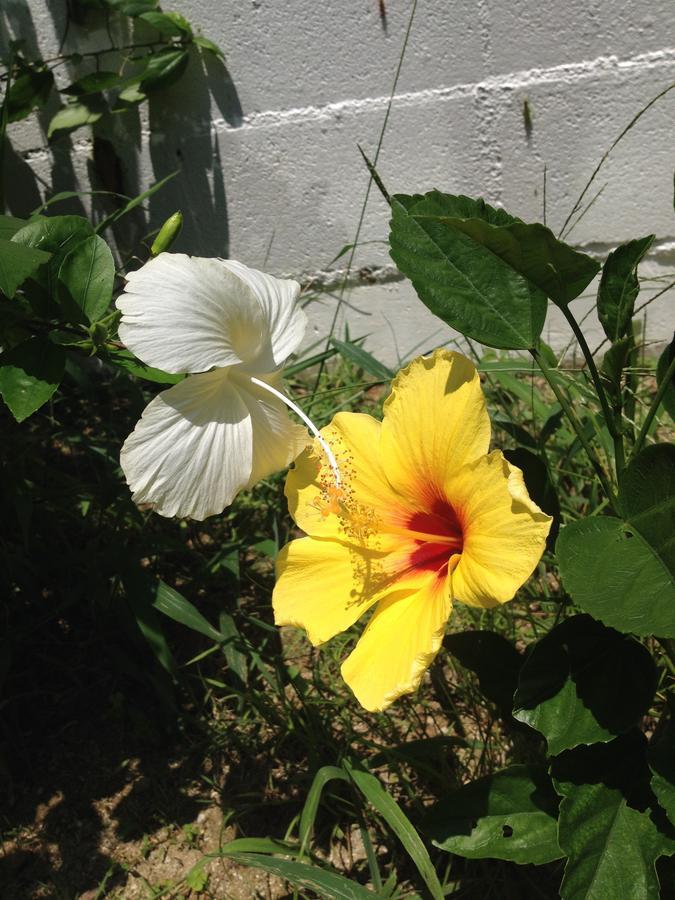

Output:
xmin=117 ymin=253 xmax=275 ymax=372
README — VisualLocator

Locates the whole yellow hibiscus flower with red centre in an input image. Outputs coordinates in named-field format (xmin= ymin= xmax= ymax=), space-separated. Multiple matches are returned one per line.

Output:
xmin=273 ymin=350 xmax=551 ymax=710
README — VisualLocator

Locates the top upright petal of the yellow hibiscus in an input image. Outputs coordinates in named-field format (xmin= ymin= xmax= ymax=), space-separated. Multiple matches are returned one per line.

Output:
xmin=380 ymin=350 xmax=490 ymax=499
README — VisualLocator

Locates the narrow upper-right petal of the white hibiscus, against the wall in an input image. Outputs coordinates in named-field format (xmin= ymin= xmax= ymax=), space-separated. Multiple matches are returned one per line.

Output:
xmin=222 ymin=259 xmax=307 ymax=372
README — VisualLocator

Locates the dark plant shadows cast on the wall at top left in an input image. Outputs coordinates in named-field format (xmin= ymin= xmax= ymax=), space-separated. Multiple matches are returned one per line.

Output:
xmin=0 ymin=0 xmax=243 ymax=258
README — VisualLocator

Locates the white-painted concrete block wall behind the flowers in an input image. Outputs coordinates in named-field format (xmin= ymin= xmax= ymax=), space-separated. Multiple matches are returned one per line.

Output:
xmin=0 ymin=0 xmax=675 ymax=362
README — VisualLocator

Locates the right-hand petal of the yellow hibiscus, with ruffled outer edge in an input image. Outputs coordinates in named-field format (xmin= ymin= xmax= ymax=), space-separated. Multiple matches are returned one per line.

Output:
xmin=445 ymin=450 xmax=552 ymax=607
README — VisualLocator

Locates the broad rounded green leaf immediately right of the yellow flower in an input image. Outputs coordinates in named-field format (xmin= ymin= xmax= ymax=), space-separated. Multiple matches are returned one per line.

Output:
xmin=556 ymin=516 xmax=675 ymax=637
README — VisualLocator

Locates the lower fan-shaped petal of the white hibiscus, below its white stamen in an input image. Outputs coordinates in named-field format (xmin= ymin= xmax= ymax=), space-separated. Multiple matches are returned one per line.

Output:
xmin=120 ymin=369 xmax=308 ymax=519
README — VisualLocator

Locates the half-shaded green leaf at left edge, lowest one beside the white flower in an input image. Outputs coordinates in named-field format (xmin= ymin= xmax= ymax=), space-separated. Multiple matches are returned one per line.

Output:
xmin=0 ymin=336 xmax=66 ymax=422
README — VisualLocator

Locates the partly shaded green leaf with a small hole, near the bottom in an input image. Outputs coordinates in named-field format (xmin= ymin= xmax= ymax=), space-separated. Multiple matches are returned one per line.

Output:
xmin=425 ymin=766 xmax=564 ymax=865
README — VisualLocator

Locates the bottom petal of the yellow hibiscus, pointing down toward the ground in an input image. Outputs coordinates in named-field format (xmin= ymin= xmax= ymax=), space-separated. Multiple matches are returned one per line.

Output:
xmin=341 ymin=573 xmax=452 ymax=711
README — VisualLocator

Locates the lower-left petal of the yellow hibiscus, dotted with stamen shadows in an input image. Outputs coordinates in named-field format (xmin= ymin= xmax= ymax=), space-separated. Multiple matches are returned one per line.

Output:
xmin=272 ymin=537 xmax=389 ymax=645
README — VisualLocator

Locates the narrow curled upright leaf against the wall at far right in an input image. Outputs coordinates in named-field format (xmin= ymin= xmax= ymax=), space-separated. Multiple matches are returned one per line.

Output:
xmin=598 ymin=234 xmax=655 ymax=341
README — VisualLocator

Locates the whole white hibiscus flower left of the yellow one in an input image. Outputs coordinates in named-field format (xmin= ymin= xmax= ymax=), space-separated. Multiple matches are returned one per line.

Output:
xmin=117 ymin=253 xmax=313 ymax=519
